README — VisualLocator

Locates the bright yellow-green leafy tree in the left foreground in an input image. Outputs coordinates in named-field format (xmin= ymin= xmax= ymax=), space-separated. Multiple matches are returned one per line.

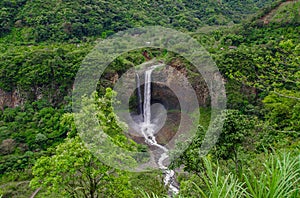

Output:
xmin=31 ymin=88 xmax=136 ymax=198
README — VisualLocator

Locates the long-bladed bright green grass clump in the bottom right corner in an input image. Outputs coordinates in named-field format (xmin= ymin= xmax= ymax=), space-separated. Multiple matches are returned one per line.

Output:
xmin=244 ymin=154 xmax=300 ymax=198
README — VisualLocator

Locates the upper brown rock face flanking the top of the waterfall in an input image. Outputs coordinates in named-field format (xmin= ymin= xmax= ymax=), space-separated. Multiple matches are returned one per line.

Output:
xmin=115 ymin=58 xmax=213 ymax=111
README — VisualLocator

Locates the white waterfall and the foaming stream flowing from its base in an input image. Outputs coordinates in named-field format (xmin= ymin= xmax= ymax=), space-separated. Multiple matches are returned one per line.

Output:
xmin=138 ymin=64 xmax=179 ymax=194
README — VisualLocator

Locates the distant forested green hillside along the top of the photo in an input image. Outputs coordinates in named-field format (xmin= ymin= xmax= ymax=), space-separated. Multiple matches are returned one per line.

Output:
xmin=0 ymin=0 xmax=272 ymax=42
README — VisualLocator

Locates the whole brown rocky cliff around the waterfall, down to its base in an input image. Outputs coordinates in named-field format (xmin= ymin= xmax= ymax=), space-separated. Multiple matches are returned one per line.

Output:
xmin=114 ymin=58 xmax=214 ymax=145
